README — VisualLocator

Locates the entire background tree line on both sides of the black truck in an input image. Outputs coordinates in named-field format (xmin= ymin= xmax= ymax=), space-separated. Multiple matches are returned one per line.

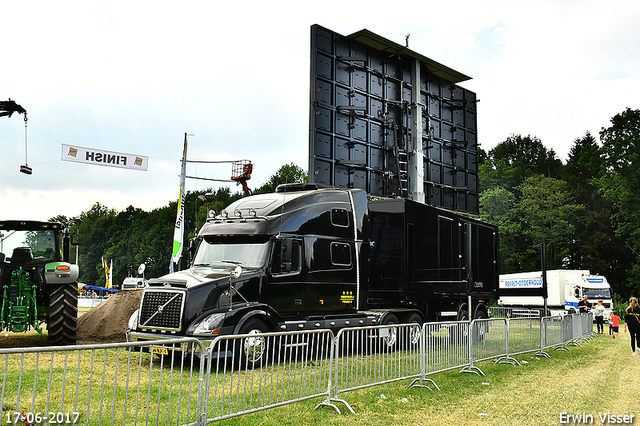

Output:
xmin=53 ymin=109 xmax=640 ymax=298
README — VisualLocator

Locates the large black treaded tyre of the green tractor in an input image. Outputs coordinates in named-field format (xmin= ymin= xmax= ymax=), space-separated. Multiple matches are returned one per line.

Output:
xmin=47 ymin=283 xmax=78 ymax=345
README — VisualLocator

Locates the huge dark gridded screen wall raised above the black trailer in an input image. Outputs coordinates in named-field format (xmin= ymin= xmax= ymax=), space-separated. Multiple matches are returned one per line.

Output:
xmin=309 ymin=25 xmax=478 ymax=214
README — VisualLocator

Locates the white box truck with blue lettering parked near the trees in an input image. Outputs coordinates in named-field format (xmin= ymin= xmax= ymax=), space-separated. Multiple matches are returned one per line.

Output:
xmin=498 ymin=269 xmax=613 ymax=315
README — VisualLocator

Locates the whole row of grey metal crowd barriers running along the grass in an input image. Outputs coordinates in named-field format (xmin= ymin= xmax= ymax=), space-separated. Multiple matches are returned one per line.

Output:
xmin=0 ymin=314 xmax=593 ymax=425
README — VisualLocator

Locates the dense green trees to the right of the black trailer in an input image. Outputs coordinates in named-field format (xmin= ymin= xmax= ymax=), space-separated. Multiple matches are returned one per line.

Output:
xmin=479 ymin=109 xmax=640 ymax=299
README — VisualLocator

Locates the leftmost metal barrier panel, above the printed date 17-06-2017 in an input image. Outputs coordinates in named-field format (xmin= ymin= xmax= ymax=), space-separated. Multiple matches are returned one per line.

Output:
xmin=0 ymin=339 xmax=204 ymax=425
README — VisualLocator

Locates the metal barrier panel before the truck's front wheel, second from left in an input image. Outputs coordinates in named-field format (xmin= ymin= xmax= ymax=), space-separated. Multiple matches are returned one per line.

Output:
xmin=204 ymin=330 xmax=334 ymax=424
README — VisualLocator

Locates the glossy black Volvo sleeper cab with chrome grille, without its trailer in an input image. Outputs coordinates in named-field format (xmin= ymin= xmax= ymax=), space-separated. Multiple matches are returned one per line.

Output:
xmin=129 ymin=187 xmax=367 ymax=350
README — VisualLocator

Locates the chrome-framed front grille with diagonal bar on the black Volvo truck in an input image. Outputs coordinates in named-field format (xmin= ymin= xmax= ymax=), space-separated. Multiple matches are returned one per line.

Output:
xmin=138 ymin=290 xmax=185 ymax=331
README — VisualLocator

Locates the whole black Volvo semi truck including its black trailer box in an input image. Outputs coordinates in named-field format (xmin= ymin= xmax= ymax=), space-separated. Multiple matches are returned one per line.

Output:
xmin=127 ymin=184 xmax=499 ymax=362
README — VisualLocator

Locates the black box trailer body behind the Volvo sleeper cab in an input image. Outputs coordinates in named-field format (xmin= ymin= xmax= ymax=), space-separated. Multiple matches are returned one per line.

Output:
xmin=368 ymin=199 xmax=498 ymax=308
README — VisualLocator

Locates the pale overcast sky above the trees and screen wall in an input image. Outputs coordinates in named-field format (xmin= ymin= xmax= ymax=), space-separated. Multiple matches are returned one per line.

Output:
xmin=0 ymin=0 xmax=640 ymax=220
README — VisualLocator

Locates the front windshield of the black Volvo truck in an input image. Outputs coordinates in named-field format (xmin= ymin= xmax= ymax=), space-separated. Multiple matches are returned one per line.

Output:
xmin=193 ymin=240 xmax=269 ymax=268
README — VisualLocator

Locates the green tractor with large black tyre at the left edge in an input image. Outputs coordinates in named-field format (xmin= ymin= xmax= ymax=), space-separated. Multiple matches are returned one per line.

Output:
xmin=0 ymin=221 xmax=78 ymax=345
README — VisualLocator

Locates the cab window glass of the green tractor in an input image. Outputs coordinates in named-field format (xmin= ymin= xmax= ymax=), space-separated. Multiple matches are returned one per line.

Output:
xmin=0 ymin=230 xmax=56 ymax=263
